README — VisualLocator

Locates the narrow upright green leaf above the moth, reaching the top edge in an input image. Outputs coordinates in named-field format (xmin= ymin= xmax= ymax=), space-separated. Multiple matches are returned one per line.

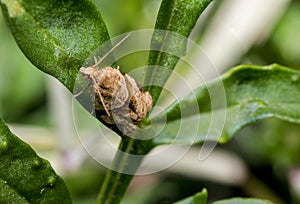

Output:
xmin=145 ymin=0 xmax=212 ymax=104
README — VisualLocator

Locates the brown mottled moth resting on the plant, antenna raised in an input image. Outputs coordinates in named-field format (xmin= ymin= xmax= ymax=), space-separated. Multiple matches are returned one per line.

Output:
xmin=80 ymin=34 xmax=152 ymax=135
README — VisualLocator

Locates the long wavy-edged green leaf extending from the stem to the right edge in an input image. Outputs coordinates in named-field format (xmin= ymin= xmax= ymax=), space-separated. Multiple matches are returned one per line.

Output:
xmin=152 ymin=64 xmax=300 ymax=144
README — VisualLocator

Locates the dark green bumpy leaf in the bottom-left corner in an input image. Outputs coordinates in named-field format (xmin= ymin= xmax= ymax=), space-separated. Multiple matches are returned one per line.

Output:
xmin=0 ymin=118 xmax=72 ymax=203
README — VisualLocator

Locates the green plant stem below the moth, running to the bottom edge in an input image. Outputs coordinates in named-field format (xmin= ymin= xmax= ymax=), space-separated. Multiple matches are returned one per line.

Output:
xmin=97 ymin=137 xmax=151 ymax=204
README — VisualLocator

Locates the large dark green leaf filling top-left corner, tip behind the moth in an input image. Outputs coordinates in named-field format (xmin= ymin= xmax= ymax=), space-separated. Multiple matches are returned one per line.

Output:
xmin=0 ymin=0 xmax=109 ymax=90
